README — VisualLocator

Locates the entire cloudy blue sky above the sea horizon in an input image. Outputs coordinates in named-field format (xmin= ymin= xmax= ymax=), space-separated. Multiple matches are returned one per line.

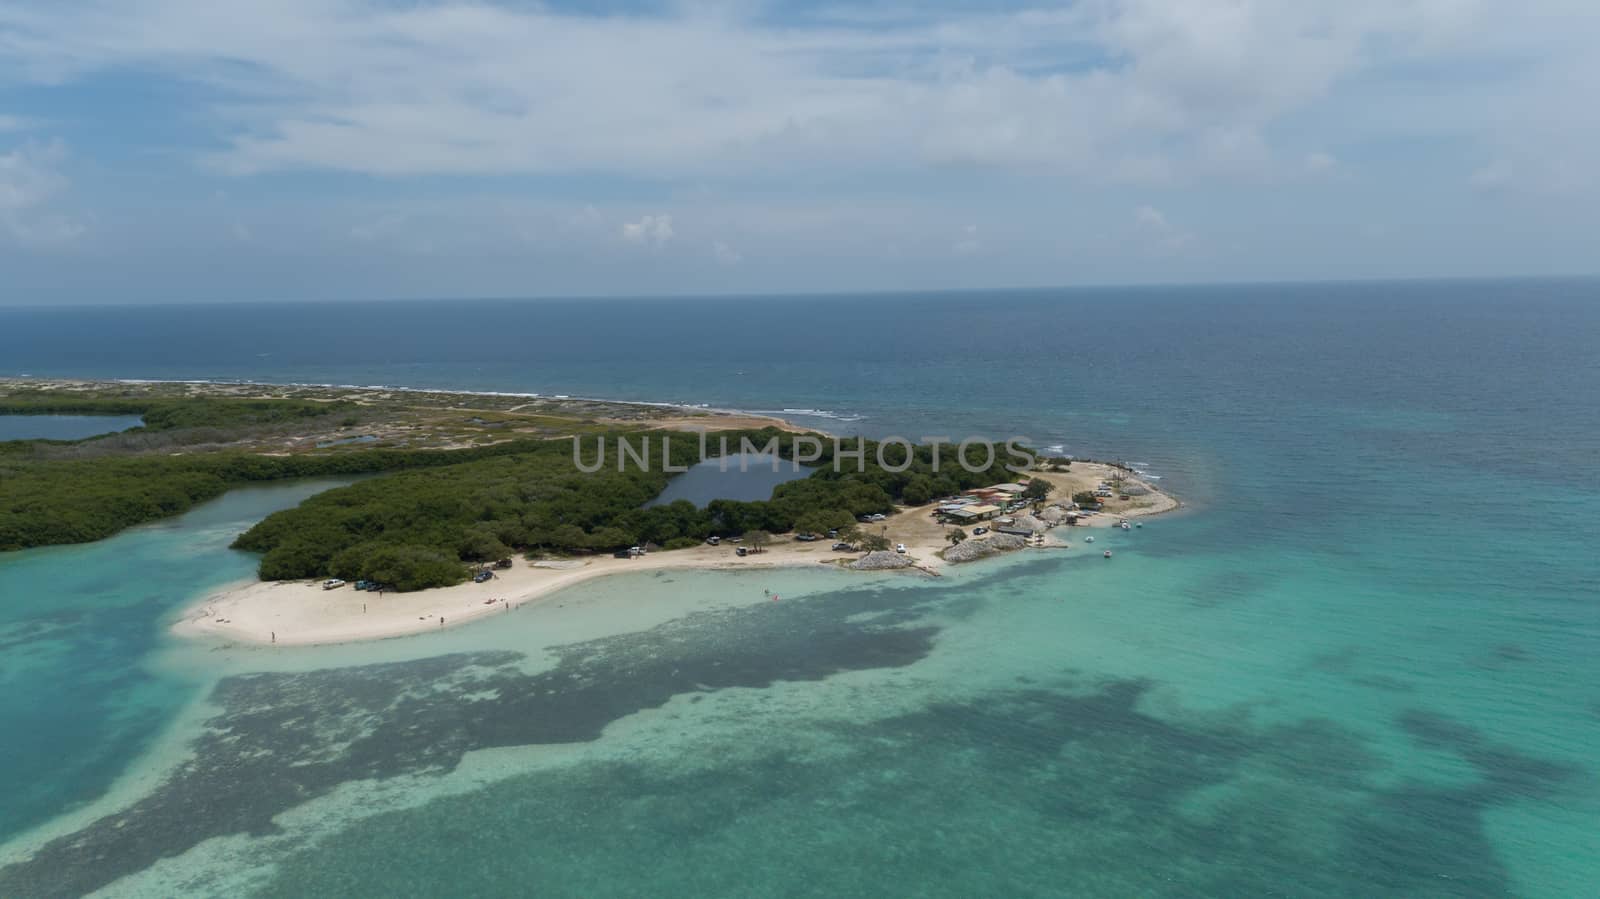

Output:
xmin=0 ymin=0 xmax=1600 ymax=304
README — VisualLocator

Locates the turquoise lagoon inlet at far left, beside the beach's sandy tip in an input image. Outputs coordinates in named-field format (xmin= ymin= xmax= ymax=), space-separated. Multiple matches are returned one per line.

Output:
xmin=0 ymin=480 xmax=356 ymax=837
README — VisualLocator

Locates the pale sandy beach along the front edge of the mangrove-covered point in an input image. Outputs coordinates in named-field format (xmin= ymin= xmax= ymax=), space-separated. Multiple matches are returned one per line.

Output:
xmin=171 ymin=462 xmax=1182 ymax=646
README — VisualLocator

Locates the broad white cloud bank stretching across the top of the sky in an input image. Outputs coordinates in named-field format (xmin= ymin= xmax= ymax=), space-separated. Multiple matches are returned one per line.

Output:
xmin=0 ymin=0 xmax=1574 ymax=181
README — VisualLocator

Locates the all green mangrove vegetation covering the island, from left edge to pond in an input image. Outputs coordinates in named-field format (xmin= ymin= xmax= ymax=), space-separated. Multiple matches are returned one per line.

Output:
xmin=0 ymin=387 xmax=1036 ymax=590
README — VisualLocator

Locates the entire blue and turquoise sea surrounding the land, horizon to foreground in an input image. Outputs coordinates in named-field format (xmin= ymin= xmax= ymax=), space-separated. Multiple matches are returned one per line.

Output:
xmin=0 ymin=280 xmax=1600 ymax=897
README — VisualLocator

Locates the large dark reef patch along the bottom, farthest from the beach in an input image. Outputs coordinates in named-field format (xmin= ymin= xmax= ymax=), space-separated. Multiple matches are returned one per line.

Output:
xmin=246 ymin=681 xmax=1562 ymax=899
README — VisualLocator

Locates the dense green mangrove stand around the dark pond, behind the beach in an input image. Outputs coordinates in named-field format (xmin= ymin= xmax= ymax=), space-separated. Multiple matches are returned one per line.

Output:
xmin=234 ymin=430 xmax=1008 ymax=590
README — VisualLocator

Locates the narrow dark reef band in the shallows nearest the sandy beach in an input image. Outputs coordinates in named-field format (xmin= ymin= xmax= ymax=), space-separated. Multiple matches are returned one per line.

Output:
xmin=0 ymin=575 xmax=934 ymax=897
